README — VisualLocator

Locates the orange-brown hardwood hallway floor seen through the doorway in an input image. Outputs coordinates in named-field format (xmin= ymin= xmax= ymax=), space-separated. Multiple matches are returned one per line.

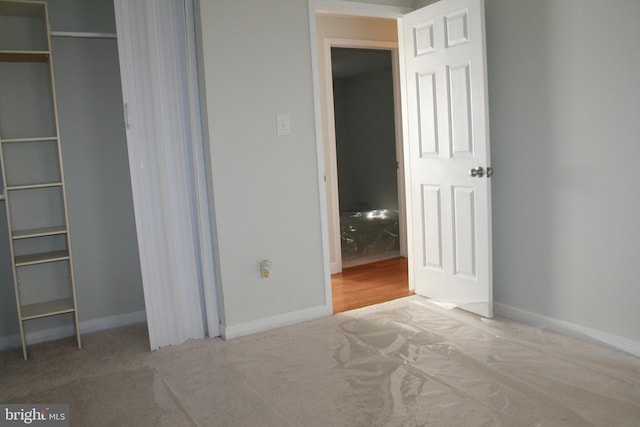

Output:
xmin=331 ymin=258 xmax=413 ymax=314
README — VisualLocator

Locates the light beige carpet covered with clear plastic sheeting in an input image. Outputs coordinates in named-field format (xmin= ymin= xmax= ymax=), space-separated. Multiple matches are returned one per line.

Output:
xmin=0 ymin=296 xmax=640 ymax=427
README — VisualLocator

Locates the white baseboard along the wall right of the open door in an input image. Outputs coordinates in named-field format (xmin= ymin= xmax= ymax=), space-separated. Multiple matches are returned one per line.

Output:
xmin=493 ymin=302 xmax=640 ymax=357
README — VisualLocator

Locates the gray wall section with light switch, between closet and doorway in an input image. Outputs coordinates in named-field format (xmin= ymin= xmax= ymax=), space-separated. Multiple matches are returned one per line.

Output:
xmin=200 ymin=0 xmax=327 ymax=327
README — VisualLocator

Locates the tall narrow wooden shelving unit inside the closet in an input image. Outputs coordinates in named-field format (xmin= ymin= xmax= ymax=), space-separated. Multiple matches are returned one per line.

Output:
xmin=0 ymin=0 xmax=82 ymax=360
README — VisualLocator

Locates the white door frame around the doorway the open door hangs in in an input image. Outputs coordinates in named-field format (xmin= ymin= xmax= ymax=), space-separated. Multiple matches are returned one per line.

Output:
xmin=308 ymin=0 xmax=414 ymax=307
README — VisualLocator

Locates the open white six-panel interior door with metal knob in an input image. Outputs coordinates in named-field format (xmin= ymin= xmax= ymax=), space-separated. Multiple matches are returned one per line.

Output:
xmin=400 ymin=0 xmax=493 ymax=317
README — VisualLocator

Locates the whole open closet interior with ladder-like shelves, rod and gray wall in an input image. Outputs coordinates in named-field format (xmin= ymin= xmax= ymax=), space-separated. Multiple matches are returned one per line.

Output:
xmin=0 ymin=0 xmax=148 ymax=358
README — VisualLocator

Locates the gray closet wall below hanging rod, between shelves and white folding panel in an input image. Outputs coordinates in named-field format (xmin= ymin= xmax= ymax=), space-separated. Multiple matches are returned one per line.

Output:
xmin=54 ymin=38 xmax=144 ymax=320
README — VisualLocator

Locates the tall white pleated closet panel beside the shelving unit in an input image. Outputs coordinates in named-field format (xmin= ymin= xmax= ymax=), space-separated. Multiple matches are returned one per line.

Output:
xmin=114 ymin=0 xmax=219 ymax=350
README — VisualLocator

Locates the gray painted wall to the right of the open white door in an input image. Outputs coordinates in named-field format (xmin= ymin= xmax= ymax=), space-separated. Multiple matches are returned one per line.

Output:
xmin=486 ymin=0 xmax=640 ymax=341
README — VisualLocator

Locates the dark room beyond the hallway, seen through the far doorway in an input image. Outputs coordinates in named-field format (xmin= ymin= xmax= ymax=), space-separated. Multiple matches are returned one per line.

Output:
xmin=331 ymin=47 xmax=400 ymax=268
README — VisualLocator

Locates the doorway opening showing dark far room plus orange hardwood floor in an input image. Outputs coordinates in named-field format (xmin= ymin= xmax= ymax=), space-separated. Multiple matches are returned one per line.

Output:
xmin=328 ymin=46 xmax=413 ymax=313
